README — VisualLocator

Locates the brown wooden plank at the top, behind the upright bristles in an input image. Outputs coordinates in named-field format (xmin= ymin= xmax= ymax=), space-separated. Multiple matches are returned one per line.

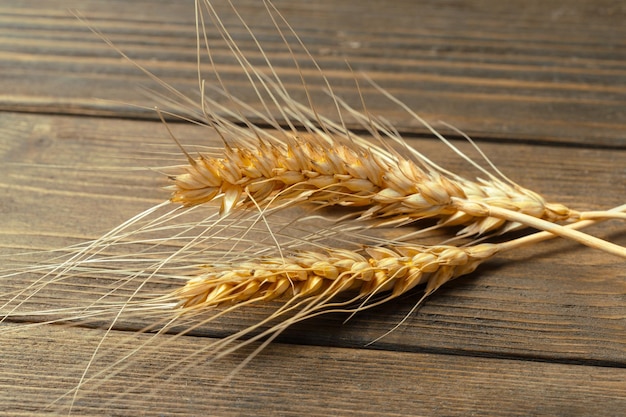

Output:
xmin=0 ymin=0 xmax=626 ymax=147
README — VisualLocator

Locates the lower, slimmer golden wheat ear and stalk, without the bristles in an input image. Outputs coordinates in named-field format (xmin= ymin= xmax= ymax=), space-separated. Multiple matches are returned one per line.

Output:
xmin=172 ymin=201 xmax=626 ymax=309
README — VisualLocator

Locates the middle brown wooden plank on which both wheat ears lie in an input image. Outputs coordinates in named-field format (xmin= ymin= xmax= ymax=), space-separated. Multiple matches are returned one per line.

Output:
xmin=0 ymin=113 xmax=626 ymax=366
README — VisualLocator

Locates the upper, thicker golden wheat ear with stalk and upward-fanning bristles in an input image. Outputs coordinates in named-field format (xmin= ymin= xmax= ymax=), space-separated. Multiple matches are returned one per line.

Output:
xmin=130 ymin=2 xmax=626 ymax=257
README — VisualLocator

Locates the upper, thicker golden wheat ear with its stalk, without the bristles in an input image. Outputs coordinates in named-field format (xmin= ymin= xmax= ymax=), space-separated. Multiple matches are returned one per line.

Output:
xmin=169 ymin=134 xmax=626 ymax=257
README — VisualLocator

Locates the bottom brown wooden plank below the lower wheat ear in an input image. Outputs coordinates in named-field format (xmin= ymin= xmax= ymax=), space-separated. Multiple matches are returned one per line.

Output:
xmin=0 ymin=326 xmax=626 ymax=416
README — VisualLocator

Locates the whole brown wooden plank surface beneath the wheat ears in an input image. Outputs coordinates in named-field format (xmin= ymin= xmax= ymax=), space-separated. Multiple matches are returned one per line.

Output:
xmin=0 ymin=0 xmax=626 ymax=416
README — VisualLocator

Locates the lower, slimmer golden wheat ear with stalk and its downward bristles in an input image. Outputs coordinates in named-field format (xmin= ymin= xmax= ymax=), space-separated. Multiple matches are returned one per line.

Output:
xmin=51 ymin=205 xmax=626 ymax=412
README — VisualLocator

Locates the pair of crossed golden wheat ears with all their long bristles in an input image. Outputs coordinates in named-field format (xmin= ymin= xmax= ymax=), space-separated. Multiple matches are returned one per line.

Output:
xmin=0 ymin=1 xmax=626 ymax=412
